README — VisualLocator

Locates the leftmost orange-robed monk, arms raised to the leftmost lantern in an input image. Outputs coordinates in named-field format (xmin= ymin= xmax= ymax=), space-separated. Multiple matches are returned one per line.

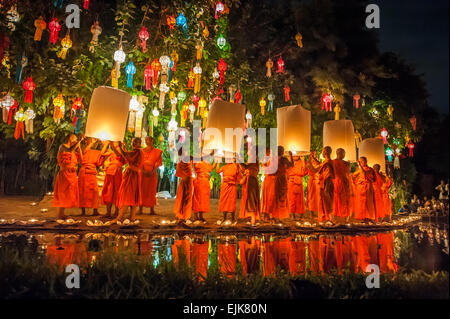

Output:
xmin=52 ymin=134 xmax=83 ymax=219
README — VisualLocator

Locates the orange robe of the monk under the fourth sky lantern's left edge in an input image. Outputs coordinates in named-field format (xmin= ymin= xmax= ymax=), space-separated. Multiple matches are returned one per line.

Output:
xmin=317 ymin=160 xmax=334 ymax=222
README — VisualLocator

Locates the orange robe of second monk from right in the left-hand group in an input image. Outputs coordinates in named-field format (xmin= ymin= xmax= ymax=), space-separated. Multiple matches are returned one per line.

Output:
xmin=117 ymin=150 xmax=142 ymax=209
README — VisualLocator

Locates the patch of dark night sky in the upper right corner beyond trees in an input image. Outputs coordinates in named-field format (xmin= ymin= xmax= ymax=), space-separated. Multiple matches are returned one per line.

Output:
xmin=372 ymin=0 xmax=449 ymax=114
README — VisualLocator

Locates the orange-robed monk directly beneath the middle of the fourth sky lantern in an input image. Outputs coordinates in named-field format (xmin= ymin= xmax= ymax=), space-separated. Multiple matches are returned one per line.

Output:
xmin=333 ymin=148 xmax=351 ymax=222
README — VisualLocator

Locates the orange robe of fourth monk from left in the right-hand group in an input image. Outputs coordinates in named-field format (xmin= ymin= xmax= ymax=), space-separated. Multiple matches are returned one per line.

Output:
xmin=239 ymin=163 xmax=261 ymax=219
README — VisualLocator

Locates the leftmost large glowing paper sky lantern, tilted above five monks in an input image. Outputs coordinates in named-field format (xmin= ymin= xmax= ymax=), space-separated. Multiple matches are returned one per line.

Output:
xmin=85 ymin=86 xmax=131 ymax=141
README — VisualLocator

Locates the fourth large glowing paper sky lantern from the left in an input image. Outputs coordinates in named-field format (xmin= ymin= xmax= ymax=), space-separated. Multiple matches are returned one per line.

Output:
xmin=323 ymin=120 xmax=356 ymax=162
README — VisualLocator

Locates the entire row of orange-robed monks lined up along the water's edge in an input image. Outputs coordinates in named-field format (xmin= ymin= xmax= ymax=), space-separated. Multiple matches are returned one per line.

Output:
xmin=53 ymin=135 xmax=392 ymax=226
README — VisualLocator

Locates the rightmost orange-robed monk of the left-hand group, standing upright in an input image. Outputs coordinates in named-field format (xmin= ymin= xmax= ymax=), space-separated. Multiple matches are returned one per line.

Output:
xmin=139 ymin=136 xmax=162 ymax=215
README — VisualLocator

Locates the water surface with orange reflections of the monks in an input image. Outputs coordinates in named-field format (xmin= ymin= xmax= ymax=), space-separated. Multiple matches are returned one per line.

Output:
xmin=0 ymin=224 xmax=448 ymax=277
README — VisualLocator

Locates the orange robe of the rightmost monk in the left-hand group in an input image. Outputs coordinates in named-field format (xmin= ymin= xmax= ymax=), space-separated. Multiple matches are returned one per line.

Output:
xmin=140 ymin=148 xmax=162 ymax=207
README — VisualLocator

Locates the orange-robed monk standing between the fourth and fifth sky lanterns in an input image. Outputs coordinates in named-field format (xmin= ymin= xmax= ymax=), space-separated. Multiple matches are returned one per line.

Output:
xmin=352 ymin=157 xmax=375 ymax=221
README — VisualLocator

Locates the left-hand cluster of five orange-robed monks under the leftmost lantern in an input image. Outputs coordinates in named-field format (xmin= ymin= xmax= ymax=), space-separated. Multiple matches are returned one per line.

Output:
xmin=53 ymin=134 xmax=162 ymax=222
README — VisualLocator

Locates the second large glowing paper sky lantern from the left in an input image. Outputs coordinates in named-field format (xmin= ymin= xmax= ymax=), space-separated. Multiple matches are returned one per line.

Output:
xmin=203 ymin=100 xmax=245 ymax=154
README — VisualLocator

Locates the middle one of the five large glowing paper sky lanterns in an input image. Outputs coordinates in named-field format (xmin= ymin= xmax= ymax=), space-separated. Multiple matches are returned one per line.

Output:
xmin=277 ymin=105 xmax=311 ymax=155
